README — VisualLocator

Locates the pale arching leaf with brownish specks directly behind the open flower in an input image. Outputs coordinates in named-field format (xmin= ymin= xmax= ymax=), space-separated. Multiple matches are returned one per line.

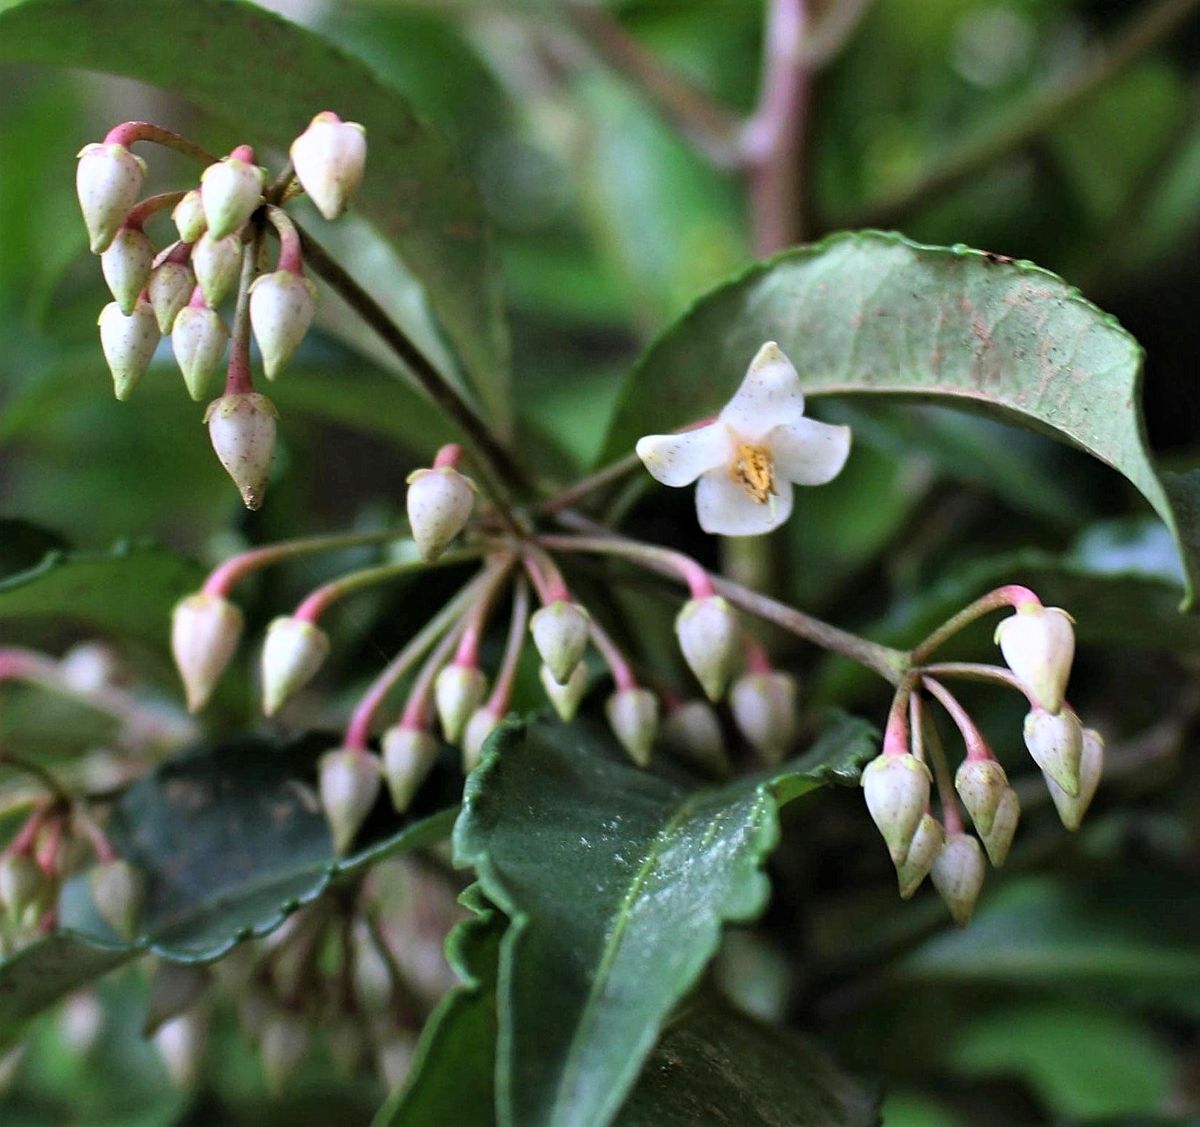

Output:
xmin=606 ymin=232 xmax=1200 ymax=605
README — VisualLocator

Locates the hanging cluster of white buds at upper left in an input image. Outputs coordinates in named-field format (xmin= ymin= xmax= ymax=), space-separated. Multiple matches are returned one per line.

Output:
xmin=76 ymin=112 xmax=366 ymax=509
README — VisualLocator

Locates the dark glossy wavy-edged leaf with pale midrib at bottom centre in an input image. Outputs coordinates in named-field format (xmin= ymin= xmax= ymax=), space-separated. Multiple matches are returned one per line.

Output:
xmin=455 ymin=718 xmax=874 ymax=1127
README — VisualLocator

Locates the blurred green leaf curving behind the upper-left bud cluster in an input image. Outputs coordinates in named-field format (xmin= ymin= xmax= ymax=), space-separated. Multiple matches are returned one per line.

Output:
xmin=0 ymin=0 xmax=509 ymax=420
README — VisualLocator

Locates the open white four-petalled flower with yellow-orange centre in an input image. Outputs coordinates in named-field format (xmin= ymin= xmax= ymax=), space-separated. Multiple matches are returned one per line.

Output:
xmin=637 ymin=341 xmax=850 ymax=536
